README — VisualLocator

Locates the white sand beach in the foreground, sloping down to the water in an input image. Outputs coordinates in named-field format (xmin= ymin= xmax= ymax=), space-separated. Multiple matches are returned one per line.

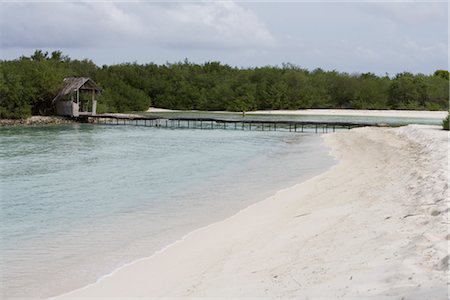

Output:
xmin=51 ymin=125 xmax=450 ymax=299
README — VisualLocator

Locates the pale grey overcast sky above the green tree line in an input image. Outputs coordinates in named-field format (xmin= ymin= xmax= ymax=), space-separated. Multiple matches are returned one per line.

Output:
xmin=0 ymin=1 xmax=449 ymax=75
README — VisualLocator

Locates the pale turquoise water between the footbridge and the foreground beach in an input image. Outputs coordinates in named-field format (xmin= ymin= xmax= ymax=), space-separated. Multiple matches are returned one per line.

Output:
xmin=0 ymin=124 xmax=334 ymax=299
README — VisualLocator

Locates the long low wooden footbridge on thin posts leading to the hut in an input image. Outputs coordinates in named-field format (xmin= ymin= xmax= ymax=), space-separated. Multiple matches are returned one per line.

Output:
xmin=78 ymin=114 xmax=385 ymax=133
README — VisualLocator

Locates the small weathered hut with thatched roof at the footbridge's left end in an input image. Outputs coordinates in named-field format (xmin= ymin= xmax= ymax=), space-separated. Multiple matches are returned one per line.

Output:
xmin=53 ymin=77 xmax=101 ymax=117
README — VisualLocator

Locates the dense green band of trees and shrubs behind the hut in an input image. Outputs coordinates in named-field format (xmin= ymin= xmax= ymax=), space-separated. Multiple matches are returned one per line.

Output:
xmin=0 ymin=50 xmax=449 ymax=118
